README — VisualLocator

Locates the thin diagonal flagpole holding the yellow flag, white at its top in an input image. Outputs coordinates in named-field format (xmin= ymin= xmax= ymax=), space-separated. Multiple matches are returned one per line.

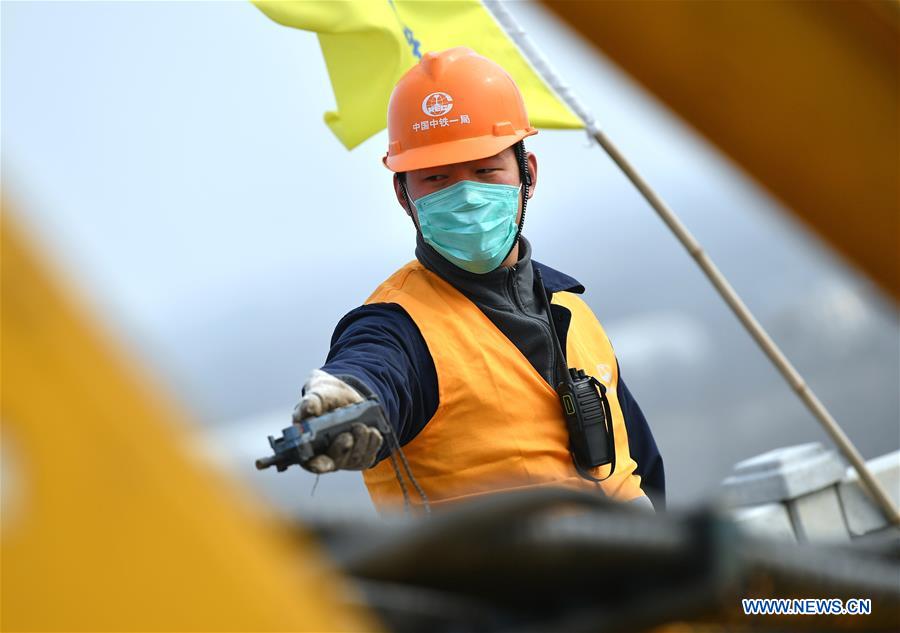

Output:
xmin=483 ymin=0 xmax=900 ymax=525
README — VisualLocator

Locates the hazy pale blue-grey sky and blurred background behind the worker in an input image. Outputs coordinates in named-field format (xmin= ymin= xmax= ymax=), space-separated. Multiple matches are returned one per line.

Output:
xmin=2 ymin=2 xmax=900 ymax=512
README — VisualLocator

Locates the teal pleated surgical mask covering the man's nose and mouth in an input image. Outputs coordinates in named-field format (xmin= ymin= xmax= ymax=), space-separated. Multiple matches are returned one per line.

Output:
xmin=413 ymin=180 xmax=522 ymax=274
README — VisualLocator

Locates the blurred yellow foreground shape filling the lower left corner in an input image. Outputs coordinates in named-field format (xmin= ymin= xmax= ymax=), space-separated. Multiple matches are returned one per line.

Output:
xmin=0 ymin=205 xmax=378 ymax=631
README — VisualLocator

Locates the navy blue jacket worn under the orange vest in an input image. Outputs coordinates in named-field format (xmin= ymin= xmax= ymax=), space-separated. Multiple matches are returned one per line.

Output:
xmin=322 ymin=261 xmax=666 ymax=511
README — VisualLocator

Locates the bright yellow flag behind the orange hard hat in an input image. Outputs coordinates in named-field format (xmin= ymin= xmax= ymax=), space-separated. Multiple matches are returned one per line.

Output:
xmin=254 ymin=0 xmax=584 ymax=149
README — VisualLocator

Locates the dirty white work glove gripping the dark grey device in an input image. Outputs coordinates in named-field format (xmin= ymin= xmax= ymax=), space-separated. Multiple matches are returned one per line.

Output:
xmin=293 ymin=369 xmax=384 ymax=474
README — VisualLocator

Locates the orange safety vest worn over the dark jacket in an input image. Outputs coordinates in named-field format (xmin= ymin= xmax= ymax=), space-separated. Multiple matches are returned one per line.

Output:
xmin=363 ymin=261 xmax=644 ymax=510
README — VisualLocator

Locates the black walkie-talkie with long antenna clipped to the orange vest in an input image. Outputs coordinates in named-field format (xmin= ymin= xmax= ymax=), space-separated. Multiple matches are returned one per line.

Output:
xmin=534 ymin=266 xmax=616 ymax=482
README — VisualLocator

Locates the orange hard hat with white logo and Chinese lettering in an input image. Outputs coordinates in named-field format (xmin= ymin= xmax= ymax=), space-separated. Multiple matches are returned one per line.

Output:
xmin=383 ymin=46 xmax=537 ymax=171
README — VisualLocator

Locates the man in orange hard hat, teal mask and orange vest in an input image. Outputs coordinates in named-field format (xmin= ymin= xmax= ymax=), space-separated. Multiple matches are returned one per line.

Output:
xmin=294 ymin=47 xmax=665 ymax=510
